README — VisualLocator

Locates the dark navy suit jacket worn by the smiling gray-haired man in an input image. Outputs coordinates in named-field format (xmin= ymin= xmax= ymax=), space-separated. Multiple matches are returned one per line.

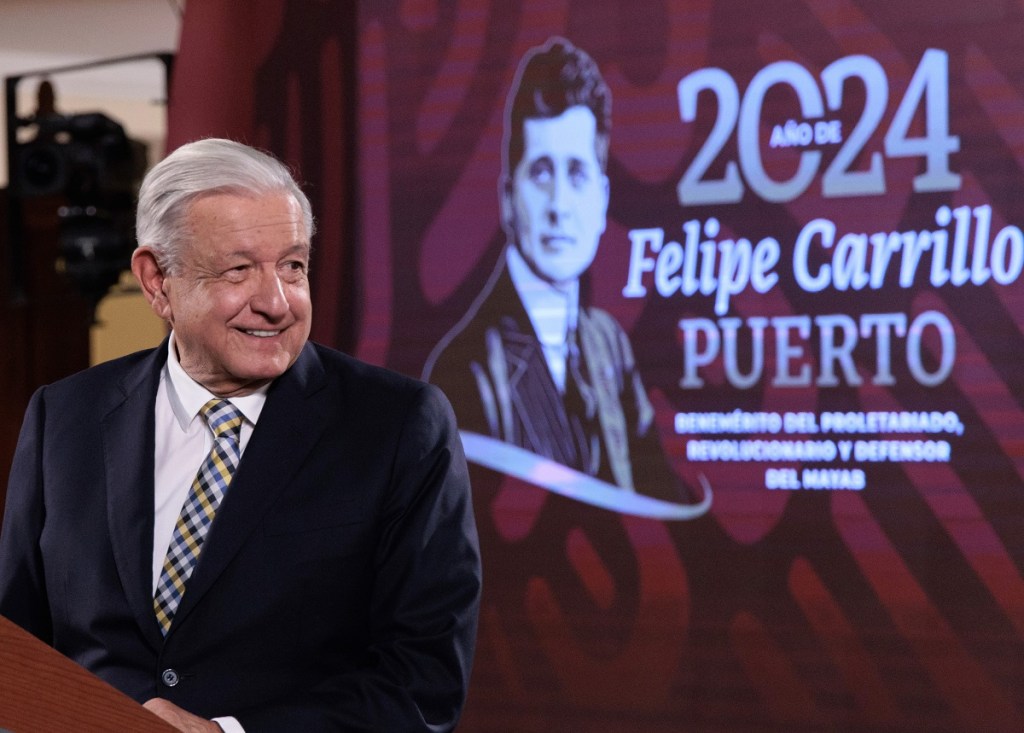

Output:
xmin=0 ymin=342 xmax=480 ymax=733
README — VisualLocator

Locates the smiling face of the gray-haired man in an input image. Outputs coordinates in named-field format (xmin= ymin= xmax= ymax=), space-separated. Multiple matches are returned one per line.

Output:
xmin=158 ymin=193 xmax=312 ymax=396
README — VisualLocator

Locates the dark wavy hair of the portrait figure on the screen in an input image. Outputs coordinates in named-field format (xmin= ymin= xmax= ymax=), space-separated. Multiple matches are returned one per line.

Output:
xmin=502 ymin=37 xmax=611 ymax=177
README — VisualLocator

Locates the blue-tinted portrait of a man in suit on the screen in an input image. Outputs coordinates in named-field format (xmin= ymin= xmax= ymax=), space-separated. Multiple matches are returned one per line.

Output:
xmin=424 ymin=38 xmax=679 ymax=500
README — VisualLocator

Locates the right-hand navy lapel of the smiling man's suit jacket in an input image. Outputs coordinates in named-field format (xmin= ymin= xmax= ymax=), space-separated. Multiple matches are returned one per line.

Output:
xmin=170 ymin=343 xmax=327 ymax=634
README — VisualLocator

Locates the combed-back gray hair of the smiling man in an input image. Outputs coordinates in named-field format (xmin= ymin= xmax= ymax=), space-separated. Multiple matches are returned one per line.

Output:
xmin=135 ymin=137 xmax=314 ymax=274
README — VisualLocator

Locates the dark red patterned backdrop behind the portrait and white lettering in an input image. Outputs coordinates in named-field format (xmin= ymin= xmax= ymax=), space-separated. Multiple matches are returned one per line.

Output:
xmin=171 ymin=0 xmax=1024 ymax=732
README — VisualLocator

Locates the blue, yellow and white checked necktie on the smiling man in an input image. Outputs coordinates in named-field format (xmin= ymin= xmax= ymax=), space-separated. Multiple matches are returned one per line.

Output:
xmin=153 ymin=399 xmax=243 ymax=636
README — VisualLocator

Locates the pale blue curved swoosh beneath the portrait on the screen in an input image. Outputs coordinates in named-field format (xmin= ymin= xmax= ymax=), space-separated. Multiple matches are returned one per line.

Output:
xmin=459 ymin=430 xmax=712 ymax=520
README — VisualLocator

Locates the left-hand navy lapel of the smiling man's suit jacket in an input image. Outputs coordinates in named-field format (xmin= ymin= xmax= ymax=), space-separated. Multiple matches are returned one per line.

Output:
xmin=100 ymin=341 xmax=167 ymax=648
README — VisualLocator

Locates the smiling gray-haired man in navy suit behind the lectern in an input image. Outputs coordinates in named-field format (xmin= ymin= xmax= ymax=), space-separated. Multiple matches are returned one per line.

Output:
xmin=0 ymin=139 xmax=480 ymax=733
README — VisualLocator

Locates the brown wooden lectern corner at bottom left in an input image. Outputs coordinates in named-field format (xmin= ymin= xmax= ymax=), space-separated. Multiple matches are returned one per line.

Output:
xmin=0 ymin=616 xmax=175 ymax=733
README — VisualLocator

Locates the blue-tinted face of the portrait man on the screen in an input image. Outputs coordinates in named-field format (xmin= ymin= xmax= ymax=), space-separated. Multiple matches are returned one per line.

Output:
xmin=506 ymin=106 xmax=608 ymax=285
